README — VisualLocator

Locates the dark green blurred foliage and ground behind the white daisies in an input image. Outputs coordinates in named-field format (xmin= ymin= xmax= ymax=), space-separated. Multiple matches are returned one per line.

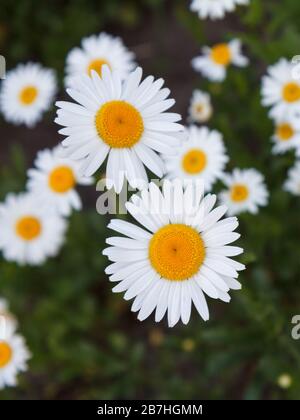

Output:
xmin=0 ymin=0 xmax=300 ymax=399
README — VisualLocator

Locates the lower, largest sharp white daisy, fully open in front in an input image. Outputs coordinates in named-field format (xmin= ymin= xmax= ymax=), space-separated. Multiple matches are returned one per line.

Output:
xmin=103 ymin=180 xmax=244 ymax=327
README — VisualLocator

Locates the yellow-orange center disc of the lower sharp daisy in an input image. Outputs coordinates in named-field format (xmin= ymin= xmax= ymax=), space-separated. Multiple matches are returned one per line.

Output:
xmin=149 ymin=224 xmax=205 ymax=281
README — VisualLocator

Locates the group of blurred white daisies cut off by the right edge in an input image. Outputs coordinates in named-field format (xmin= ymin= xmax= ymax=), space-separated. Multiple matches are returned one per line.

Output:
xmin=262 ymin=58 xmax=300 ymax=196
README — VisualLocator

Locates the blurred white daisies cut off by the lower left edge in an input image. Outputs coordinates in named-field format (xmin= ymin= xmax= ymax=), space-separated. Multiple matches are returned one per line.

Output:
xmin=0 ymin=298 xmax=30 ymax=389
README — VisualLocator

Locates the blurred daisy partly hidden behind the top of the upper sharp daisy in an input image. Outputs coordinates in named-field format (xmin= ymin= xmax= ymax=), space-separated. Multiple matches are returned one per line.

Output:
xmin=66 ymin=32 xmax=136 ymax=87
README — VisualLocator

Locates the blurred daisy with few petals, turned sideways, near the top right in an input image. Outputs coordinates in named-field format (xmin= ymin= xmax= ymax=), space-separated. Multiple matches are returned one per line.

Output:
xmin=192 ymin=39 xmax=248 ymax=82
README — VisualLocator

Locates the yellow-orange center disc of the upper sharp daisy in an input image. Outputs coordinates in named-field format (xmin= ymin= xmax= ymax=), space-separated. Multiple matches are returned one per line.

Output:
xmin=95 ymin=101 xmax=144 ymax=148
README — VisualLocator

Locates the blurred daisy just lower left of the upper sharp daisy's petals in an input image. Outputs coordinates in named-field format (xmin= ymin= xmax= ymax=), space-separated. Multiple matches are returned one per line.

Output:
xmin=27 ymin=146 xmax=93 ymax=216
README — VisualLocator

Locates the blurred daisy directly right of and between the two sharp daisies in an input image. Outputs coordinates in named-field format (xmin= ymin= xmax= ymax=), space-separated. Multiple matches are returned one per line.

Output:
xmin=165 ymin=126 xmax=228 ymax=191
